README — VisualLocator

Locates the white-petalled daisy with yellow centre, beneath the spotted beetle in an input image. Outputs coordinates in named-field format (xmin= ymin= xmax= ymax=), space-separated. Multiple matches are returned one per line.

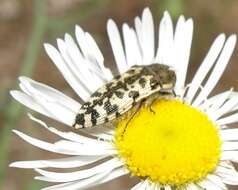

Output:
xmin=10 ymin=8 xmax=238 ymax=190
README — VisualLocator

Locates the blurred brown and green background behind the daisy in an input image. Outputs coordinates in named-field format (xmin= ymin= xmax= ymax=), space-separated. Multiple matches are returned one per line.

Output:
xmin=0 ymin=0 xmax=238 ymax=190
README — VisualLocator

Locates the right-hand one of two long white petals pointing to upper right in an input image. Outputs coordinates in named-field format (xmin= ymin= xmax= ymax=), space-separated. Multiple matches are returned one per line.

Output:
xmin=192 ymin=35 xmax=236 ymax=107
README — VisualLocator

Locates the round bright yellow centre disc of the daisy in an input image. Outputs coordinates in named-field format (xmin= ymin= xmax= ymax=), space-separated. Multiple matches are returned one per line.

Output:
xmin=115 ymin=99 xmax=221 ymax=186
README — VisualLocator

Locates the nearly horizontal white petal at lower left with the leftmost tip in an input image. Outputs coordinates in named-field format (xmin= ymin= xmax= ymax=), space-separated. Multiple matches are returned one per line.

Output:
xmin=9 ymin=156 xmax=105 ymax=168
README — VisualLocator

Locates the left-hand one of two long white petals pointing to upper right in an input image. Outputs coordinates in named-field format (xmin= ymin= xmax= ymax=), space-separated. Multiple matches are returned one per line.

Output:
xmin=186 ymin=34 xmax=225 ymax=103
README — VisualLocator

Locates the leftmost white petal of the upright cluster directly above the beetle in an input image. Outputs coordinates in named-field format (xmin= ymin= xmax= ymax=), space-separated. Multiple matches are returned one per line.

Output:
xmin=107 ymin=19 xmax=128 ymax=73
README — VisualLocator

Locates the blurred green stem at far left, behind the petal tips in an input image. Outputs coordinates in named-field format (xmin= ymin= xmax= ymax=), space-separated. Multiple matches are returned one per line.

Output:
xmin=0 ymin=0 xmax=47 ymax=186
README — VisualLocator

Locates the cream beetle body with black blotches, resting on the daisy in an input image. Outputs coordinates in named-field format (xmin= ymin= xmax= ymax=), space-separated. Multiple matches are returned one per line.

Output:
xmin=73 ymin=64 xmax=176 ymax=129
